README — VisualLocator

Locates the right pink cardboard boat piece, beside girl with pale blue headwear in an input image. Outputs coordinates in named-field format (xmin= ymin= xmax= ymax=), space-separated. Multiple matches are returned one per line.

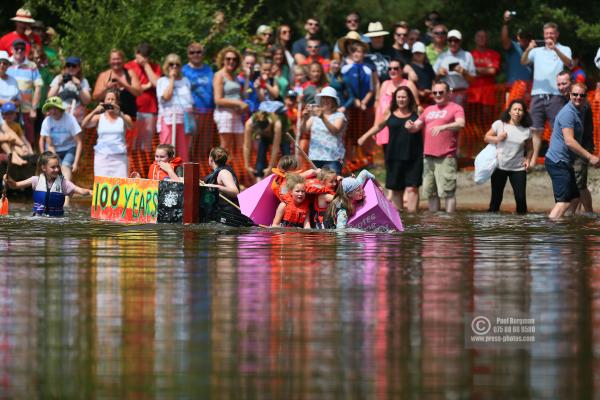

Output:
xmin=348 ymin=179 xmax=404 ymax=232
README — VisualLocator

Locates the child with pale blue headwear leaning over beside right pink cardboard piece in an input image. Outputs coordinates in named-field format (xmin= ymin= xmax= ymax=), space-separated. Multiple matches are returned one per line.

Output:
xmin=324 ymin=169 xmax=379 ymax=229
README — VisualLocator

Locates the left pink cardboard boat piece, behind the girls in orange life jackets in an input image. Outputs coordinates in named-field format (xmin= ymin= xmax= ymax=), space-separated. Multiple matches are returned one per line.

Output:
xmin=238 ymin=174 xmax=279 ymax=225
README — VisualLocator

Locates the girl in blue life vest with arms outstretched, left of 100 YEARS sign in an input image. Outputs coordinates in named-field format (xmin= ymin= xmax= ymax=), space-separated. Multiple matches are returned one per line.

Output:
xmin=3 ymin=151 xmax=92 ymax=217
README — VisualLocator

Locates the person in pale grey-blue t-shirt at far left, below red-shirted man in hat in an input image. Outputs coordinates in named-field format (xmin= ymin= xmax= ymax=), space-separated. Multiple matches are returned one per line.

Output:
xmin=7 ymin=39 xmax=44 ymax=143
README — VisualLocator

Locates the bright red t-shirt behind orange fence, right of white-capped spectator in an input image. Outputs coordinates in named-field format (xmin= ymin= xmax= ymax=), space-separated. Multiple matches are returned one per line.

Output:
xmin=468 ymin=49 xmax=504 ymax=106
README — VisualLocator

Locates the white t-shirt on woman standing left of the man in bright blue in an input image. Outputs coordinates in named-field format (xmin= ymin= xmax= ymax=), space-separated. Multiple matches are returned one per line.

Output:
xmin=156 ymin=76 xmax=194 ymax=125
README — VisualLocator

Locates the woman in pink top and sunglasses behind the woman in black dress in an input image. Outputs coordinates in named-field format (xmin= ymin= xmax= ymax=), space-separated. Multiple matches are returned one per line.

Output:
xmin=375 ymin=60 xmax=421 ymax=147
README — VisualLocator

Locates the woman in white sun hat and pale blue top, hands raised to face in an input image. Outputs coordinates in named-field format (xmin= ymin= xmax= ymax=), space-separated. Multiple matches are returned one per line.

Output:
xmin=300 ymin=86 xmax=347 ymax=175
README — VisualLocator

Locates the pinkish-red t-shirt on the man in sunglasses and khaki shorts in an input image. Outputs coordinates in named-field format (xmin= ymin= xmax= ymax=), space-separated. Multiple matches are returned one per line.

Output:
xmin=419 ymin=102 xmax=465 ymax=157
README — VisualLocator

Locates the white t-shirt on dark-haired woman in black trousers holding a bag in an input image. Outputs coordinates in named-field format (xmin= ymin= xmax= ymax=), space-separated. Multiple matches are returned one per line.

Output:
xmin=492 ymin=120 xmax=531 ymax=171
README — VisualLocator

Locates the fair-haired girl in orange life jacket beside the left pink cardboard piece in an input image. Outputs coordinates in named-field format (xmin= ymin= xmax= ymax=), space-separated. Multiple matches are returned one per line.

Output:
xmin=272 ymin=173 xmax=310 ymax=229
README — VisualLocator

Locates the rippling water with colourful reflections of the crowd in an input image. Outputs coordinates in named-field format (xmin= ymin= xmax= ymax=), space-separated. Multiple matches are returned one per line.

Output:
xmin=0 ymin=203 xmax=600 ymax=399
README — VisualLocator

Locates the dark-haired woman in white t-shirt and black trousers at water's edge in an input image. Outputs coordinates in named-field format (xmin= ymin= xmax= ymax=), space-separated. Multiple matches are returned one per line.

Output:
xmin=484 ymin=100 xmax=533 ymax=214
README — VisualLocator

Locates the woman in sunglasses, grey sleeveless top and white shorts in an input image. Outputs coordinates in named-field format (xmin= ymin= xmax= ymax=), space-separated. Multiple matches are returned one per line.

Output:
xmin=213 ymin=47 xmax=248 ymax=154
